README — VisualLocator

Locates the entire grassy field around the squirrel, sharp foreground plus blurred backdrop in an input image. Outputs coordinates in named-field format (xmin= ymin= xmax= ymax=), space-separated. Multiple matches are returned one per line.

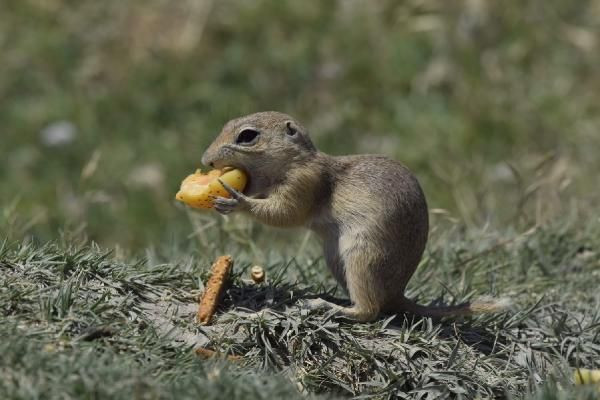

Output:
xmin=0 ymin=0 xmax=600 ymax=399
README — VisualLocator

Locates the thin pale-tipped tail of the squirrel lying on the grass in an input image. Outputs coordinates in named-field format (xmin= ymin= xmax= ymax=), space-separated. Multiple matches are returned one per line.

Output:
xmin=395 ymin=297 xmax=511 ymax=318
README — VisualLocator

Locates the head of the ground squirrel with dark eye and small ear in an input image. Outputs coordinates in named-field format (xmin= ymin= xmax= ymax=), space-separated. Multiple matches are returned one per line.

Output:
xmin=202 ymin=111 xmax=317 ymax=182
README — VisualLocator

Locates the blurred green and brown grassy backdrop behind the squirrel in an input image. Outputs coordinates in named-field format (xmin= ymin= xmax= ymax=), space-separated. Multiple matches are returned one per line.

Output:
xmin=0 ymin=0 xmax=600 ymax=251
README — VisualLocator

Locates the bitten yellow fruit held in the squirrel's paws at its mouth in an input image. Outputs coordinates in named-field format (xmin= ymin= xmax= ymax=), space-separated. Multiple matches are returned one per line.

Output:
xmin=175 ymin=168 xmax=248 ymax=209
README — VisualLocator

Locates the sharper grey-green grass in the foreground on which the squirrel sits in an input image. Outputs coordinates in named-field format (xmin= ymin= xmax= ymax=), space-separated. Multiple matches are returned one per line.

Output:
xmin=0 ymin=223 xmax=600 ymax=399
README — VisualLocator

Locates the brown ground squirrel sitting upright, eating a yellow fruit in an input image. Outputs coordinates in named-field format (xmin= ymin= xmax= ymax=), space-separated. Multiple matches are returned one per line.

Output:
xmin=202 ymin=112 xmax=504 ymax=321
